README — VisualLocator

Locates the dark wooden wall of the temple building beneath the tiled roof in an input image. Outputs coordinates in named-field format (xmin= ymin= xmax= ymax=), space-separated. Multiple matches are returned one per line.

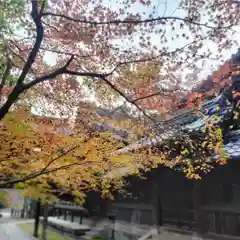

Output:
xmin=109 ymin=161 xmax=240 ymax=236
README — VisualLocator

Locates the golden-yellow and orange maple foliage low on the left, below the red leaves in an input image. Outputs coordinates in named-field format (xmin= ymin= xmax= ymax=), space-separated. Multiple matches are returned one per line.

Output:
xmin=0 ymin=108 xmax=137 ymax=201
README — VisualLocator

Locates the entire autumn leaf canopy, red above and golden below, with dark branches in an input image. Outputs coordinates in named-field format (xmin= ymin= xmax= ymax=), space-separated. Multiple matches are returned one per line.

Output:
xmin=0 ymin=0 xmax=240 ymax=201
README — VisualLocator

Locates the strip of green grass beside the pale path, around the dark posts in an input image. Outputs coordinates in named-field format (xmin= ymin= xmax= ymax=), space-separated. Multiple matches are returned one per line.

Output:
xmin=18 ymin=223 xmax=73 ymax=240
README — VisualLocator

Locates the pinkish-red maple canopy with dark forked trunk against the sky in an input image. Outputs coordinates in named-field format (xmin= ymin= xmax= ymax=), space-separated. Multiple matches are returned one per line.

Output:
xmin=0 ymin=0 xmax=239 ymax=118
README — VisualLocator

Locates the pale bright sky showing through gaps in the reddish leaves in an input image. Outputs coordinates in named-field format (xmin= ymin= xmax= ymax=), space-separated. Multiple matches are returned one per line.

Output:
xmin=11 ymin=0 xmax=240 ymax=116
